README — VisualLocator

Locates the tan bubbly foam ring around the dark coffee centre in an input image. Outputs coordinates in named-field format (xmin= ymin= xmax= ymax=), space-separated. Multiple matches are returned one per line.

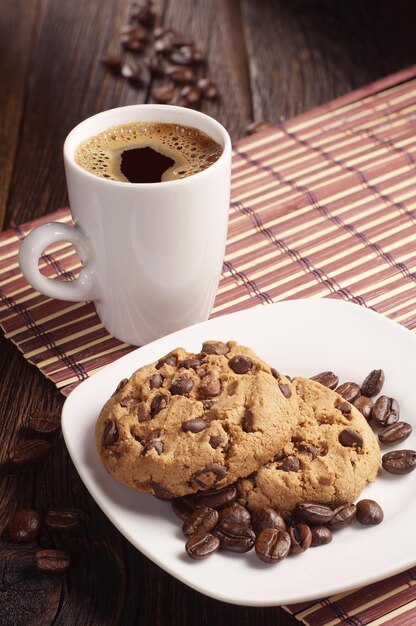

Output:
xmin=74 ymin=122 xmax=223 ymax=183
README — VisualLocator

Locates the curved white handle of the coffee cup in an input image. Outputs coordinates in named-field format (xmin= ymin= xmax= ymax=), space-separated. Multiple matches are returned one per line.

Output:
xmin=19 ymin=222 xmax=98 ymax=302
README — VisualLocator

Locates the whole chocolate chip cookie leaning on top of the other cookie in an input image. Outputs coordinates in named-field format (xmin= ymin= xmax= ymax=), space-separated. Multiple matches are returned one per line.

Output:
xmin=96 ymin=341 xmax=298 ymax=499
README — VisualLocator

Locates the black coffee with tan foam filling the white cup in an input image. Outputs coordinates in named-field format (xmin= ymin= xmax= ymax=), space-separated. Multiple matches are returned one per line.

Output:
xmin=75 ymin=122 xmax=223 ymax=183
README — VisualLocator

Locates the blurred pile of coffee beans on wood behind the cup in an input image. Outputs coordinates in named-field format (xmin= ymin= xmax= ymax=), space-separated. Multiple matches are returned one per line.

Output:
xmin=102 ymin=0 xmax=218 ymax=107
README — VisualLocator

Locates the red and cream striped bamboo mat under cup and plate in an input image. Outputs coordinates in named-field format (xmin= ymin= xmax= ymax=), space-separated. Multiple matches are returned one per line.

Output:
xmin=0 ymin=66 xmax=416 ymax=626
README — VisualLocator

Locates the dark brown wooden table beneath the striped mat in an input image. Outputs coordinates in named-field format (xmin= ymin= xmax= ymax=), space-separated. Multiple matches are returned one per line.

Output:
xmin=0 ymin=0 xmax=416 ymax=626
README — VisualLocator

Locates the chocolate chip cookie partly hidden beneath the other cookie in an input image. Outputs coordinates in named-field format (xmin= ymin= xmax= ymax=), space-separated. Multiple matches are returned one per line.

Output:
xmin=237 ymin=378 xmax=380 ymax=513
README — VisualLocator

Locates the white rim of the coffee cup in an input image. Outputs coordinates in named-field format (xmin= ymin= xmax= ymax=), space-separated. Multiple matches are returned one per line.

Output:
xmin=63 ymin=104 xmax=232 ymax=189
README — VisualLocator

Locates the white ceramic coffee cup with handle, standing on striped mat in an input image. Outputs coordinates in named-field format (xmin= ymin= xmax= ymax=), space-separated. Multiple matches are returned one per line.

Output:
xmin=19 ymin=104 xmax=231 ymax=345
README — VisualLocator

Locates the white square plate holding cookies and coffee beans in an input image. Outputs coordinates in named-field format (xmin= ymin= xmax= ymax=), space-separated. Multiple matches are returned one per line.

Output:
xmin=62 ymin=299 xmax=416 ymax=606
